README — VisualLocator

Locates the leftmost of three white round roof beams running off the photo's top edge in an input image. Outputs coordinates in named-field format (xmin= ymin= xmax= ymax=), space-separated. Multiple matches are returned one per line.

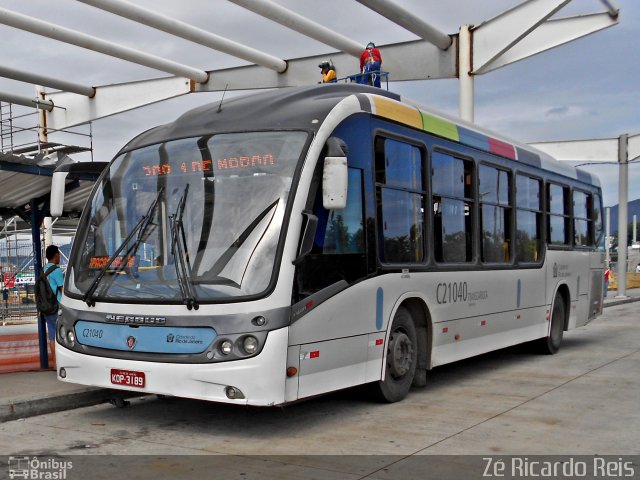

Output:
xmin=78 ymin=0 xmax=287 ymax=72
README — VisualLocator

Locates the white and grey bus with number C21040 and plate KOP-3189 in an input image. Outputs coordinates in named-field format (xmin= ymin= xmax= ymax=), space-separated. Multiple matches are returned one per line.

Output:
xmin=52 ymin=84 xmax=603 ymax=405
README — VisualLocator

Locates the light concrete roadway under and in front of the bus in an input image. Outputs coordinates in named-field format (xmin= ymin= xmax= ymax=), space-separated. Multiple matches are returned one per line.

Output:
xmin=0 ymin=303 xmax=640 ymax=480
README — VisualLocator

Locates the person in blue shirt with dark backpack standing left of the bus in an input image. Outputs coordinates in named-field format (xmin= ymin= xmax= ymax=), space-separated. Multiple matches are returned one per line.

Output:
xmin=36 ymin=245 xmax=64 ymax=366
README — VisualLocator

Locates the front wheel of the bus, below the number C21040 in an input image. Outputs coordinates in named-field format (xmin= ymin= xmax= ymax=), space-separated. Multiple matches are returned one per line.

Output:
xmin=375 ymin=307 xmax=418 ymax=403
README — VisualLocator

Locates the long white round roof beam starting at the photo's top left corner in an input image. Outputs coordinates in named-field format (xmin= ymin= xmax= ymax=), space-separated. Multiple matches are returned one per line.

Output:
xmin=0 ymin=8 xmax=209 ymax=82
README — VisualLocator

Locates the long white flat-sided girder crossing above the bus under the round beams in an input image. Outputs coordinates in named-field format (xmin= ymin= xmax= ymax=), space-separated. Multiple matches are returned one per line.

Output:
xmin=46 ymin=40 xmax=456 ymax=130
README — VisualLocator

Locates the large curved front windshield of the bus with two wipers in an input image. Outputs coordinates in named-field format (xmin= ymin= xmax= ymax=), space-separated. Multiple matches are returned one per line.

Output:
xmin=67 ymin=132 xmax=307 ymax=303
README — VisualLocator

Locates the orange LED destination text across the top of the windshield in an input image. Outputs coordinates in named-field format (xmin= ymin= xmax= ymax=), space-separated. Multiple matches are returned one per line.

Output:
xmin=142 ymin=153 xmax=276 ymax=177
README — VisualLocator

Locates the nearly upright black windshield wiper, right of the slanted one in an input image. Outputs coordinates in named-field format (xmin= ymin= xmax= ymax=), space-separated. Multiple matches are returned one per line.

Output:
xmin=169 ymin=184 xmax=200 ymax=310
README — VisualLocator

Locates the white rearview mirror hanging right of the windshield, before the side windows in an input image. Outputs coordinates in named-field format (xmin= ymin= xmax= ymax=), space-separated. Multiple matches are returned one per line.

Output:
xmin=322 ymin=137 xmax=348 ymax=210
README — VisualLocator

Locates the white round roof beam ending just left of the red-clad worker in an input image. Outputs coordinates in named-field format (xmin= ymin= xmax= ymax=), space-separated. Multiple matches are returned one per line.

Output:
xmin=229 ymin=0 xmax=364 ymax=58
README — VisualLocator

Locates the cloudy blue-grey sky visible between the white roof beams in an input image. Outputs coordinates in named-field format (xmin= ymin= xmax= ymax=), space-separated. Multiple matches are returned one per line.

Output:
xmin=0 ymin=0 xmax=640 ymax=205
